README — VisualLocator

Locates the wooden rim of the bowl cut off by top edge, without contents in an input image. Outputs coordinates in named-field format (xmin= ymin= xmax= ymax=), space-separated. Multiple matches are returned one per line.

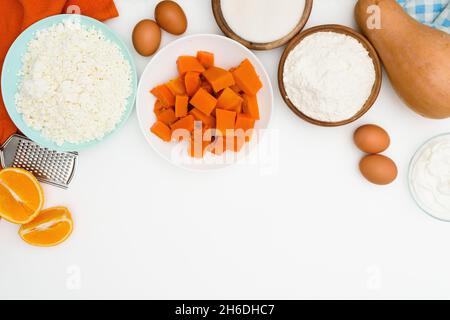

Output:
xmin=211 ymin=0 xmax=313 ymax=50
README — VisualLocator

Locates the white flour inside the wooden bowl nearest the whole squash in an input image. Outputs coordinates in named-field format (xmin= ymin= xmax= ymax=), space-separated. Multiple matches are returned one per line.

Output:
xmin=283 ymin=32 xmax=376 ymax=122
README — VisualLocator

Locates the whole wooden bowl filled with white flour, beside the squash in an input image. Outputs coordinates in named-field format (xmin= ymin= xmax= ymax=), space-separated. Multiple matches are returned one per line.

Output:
xmin=278 ymin=25 xmax=382 ymax=127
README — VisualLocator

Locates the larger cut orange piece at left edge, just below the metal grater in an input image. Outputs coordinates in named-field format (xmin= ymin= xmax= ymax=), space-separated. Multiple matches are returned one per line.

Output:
xmin=0 ymin=168 xmax=44 ymax=224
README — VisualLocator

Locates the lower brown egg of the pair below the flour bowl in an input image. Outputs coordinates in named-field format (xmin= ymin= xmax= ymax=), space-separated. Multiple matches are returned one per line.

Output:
xmin=359 ymin=154 xmax=398 ymax=185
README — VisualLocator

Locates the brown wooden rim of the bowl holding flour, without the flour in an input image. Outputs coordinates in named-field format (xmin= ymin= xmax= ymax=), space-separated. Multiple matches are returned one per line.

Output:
xmin=278 ymin=24 xmax=382 ymax=127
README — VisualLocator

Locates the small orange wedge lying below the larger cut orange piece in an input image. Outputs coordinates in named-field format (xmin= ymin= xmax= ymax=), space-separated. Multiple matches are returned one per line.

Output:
xmin=19 ymin=207 xmax=73 ymax=247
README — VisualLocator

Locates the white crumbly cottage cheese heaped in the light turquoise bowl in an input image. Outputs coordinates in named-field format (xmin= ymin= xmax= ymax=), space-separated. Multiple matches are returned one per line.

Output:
xmin=16 ymin=19 xmax=132 ymax=145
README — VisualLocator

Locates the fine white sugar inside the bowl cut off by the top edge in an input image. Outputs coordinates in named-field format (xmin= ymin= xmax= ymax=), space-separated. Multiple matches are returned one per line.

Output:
xmin=220 ymin=0 xmax=305 ymax=43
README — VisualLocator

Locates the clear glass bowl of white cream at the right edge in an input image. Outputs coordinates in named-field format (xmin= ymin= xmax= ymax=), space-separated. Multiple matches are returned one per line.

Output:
xmin=409 ymin=134 xmax=450 ymax=221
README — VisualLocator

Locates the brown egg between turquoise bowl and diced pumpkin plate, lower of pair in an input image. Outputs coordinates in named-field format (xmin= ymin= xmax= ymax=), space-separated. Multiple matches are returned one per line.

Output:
xmin=133 ymin=20 xmax=161 ymax=57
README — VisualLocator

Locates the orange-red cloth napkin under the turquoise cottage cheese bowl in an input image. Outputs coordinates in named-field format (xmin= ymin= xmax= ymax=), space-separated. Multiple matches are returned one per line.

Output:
xmin=0 ymin=0 xmax=119 ymax=144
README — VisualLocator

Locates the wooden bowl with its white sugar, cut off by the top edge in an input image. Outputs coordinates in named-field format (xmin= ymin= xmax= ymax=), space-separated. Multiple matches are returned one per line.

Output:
xmin=211 ymin=0 xmax=313 ymax=50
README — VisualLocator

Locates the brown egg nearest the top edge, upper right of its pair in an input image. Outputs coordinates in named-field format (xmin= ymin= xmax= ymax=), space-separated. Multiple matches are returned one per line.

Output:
xmin=155 ymin=0 xmax=187 ymax=35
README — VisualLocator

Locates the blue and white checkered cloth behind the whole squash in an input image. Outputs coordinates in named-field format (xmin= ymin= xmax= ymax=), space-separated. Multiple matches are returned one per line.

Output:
xmin=397 ymin=0 xmax=450 ymax=33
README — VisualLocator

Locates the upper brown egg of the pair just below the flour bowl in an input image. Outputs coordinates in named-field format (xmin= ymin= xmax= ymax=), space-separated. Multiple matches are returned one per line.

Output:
xmin=353 ymin=124 xmax=391 ymax=153
